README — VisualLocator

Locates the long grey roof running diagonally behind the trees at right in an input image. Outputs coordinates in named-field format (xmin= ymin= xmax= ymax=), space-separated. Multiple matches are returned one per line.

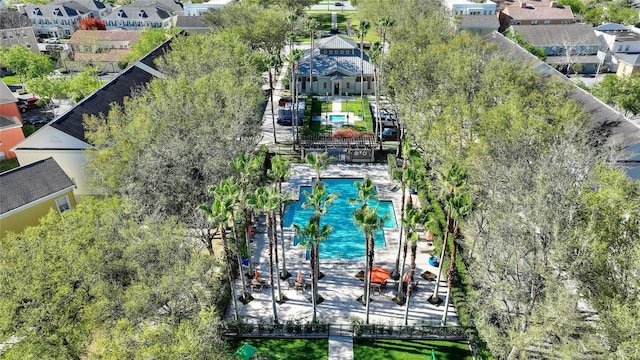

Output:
xmin=484 ymin=31 xmax=640 ymax=149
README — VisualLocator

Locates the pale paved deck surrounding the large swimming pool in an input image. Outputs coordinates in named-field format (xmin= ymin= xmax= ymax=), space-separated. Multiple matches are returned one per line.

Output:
xmin=228 ymin=164 xmax=457 ymax=325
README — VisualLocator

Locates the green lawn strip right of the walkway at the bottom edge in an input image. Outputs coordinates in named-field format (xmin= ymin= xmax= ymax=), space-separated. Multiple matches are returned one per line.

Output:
xmin=353 ymin=339 xmax=473 ymax=360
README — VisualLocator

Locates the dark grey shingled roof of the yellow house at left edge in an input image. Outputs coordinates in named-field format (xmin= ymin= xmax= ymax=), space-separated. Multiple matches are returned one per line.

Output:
xmin=0 ymin=158 xmax=75 ymax=214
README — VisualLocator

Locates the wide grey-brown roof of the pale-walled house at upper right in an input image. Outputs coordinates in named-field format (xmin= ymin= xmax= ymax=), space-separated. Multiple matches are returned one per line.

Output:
xmin=511 ymin=24 xmax=600 ymax=46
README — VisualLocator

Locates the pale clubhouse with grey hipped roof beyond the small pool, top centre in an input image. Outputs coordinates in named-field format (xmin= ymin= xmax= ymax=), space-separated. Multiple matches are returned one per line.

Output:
xmin=297 ymin=35 xmax=374 ymax=95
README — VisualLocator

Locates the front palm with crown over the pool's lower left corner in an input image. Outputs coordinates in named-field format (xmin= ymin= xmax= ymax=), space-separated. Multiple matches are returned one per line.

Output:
xmin=293 ymin=215 xmax=333 ymax=322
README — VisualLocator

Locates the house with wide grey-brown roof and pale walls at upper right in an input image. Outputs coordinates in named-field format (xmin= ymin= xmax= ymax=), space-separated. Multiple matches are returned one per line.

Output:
xmin=511 ymin=24 xmax=604 ymax=74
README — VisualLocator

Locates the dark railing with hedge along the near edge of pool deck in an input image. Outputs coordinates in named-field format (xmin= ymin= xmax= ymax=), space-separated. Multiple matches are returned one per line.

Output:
xmin=223 ymin=320 xmax=470 ymax=340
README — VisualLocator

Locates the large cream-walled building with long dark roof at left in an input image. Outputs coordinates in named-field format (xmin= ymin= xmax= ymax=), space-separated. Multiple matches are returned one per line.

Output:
xmin=11 ymin=38 xmax=173 ymax=196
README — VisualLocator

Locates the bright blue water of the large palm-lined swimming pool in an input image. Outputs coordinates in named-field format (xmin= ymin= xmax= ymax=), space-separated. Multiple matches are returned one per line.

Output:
xmin=284 ymin=179 xmax=397 ymax=260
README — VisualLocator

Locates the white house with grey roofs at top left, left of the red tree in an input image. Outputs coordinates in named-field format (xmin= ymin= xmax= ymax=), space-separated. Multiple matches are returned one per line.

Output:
xmin=24 ymin=1 xmax=93 ymax=37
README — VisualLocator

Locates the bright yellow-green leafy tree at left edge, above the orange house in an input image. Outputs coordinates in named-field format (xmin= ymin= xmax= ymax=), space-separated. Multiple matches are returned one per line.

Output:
xmin=0 ymin=45 xmax=53 ymax=84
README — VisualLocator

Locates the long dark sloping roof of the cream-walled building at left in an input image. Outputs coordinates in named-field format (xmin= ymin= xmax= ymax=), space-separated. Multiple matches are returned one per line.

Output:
xmin=46 ymin=34 xmax=173 ymax=142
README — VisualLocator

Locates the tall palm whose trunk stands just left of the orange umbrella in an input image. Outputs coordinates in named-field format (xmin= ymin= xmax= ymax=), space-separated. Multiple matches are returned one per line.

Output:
xmin=353 ymin=205 xmax=388 ymax=324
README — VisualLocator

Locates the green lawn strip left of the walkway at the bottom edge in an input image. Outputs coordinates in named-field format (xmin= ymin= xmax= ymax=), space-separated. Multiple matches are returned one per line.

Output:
xmin=230 ymin=339 xmax=329 ymax=360
